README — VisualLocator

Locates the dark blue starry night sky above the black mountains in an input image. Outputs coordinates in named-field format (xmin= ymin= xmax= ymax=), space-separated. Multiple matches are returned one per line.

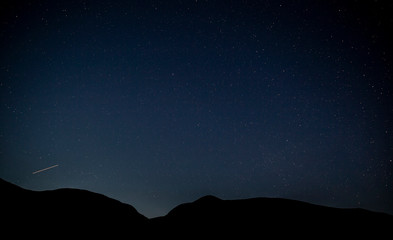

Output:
xmin=0 ymin=0 xmax=393 ymax=217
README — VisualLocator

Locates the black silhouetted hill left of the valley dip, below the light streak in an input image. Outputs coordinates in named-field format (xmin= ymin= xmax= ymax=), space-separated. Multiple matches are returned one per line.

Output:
xmin=0 ymin=180 xmax=148 ymax=236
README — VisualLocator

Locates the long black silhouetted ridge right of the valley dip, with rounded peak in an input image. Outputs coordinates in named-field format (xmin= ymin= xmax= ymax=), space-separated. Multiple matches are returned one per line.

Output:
xmin=152 ymin=196 xmax=393 ymax=238
